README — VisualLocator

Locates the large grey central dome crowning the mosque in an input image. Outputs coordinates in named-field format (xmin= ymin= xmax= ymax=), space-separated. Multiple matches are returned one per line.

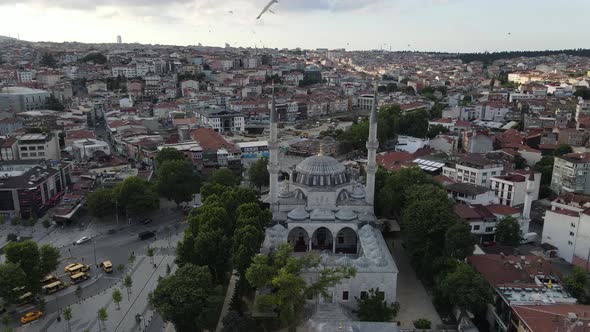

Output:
xmin=294 ymin=155 xmax=350 ymax=187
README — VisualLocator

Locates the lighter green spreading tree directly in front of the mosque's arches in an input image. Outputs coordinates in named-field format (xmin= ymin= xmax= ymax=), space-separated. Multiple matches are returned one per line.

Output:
xmin=246 ymin=243 xmax=356 ymax=325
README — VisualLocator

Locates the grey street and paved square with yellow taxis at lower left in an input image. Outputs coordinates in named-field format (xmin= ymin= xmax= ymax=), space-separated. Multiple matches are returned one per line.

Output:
xmin=2 ymin=204 xmax=186 ymax=331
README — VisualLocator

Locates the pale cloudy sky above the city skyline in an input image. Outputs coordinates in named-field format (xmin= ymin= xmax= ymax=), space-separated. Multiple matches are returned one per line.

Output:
xmin=0 ymin=0 xmax=590 ymax=52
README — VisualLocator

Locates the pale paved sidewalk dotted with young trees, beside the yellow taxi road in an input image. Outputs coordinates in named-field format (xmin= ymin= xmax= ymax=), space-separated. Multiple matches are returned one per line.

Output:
xmin=47 ymin=256 xmax=176 ymax=332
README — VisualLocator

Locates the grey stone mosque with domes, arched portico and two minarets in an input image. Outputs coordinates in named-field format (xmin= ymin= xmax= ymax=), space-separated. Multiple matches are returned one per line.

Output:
xmin=262 ymin=89 xmax=398 ymax=308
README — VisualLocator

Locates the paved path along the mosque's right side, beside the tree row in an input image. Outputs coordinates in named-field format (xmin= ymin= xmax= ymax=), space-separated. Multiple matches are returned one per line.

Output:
xmin=388 ymin=241 xmax=442 ymax=329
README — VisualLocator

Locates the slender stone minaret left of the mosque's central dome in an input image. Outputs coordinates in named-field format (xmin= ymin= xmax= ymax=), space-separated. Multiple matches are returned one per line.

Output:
xmin=268 ymin=82 xmax=279 ymax=211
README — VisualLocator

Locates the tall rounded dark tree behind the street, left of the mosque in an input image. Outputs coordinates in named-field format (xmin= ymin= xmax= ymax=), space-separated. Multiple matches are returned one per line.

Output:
xmin=157 ymin=160 xmax=201 ymax=206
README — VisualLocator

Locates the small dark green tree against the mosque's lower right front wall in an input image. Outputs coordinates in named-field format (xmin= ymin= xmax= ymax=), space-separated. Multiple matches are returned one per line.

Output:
xmin=353 ymin=288 xmax=399 ymax=322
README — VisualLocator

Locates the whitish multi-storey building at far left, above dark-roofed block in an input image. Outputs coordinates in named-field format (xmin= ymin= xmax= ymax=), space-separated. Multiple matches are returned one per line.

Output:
xmin=17 ymin=132 xmax=60 ymax=160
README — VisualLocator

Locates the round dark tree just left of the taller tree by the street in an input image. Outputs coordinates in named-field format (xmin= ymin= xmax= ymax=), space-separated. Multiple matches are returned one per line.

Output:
xmin=113 ymin=176 xmax=160 ymax=213
